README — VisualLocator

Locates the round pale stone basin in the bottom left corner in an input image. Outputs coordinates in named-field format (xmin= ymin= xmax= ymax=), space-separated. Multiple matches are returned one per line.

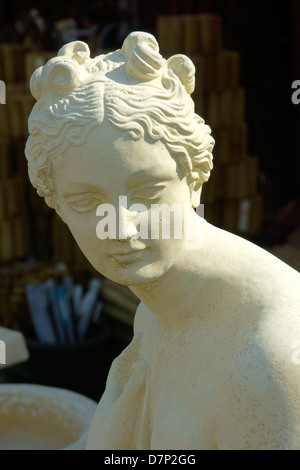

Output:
xmin=0 ymin=384 xmax=97 ymax=450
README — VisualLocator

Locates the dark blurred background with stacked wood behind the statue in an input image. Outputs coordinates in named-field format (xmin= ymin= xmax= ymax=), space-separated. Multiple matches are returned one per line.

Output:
xmin=0 ymin=0 xmax=300 ymax=399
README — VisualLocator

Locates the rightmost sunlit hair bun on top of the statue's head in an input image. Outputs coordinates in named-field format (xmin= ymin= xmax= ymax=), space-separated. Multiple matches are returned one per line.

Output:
xmin=167 ymin=54 xmax=195 ymax=95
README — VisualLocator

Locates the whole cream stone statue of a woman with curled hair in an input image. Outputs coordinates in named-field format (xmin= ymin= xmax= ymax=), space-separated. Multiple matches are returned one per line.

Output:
xmin=26 ymin=32 xmax=300 ymax=450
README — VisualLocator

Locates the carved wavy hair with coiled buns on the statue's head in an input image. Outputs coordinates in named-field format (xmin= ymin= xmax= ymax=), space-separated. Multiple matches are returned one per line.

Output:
xmin=25 ymin=32 xmax=214 ymax=208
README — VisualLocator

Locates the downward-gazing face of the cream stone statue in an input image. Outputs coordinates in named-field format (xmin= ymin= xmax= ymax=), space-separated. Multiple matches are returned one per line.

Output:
xmin=54 ymin=121 xmax=194 ymax=286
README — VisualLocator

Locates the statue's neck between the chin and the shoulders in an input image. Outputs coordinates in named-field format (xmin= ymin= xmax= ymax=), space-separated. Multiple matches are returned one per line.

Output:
xmin=130 ymin=221 xmax=220 ymax=330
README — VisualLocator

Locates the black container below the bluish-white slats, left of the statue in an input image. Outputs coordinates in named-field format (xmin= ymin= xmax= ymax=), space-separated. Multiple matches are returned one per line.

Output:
xmin=23 ymin=326 xmax=122 ymax=401
